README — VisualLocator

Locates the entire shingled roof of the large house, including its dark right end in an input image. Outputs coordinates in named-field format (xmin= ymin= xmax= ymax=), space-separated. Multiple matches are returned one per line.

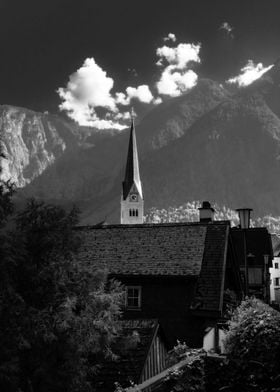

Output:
xmin=77 ymin=221 xmax=230 ymax=312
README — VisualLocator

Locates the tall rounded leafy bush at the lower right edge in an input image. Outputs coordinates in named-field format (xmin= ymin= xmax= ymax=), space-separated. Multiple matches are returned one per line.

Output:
xmin=225 ymin=298 xmax=280 ymax=392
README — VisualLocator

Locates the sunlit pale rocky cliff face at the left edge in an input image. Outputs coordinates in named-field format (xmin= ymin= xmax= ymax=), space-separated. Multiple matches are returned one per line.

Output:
xmin=0 ymin=105 xmax=78 ymax=187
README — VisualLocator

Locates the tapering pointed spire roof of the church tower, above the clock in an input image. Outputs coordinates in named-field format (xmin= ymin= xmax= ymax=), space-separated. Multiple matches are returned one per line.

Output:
xmin=123 ymin=108 xmax=143 ymax=200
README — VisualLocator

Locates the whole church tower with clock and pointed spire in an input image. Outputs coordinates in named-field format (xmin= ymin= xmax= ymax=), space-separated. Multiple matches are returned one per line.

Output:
xmin=121 ymin=114 xmax=144 ymax=224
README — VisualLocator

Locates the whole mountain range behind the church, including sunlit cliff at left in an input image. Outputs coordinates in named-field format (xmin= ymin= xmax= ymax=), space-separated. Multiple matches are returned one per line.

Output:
xmin=0 ymin=64 xmax=280 ymax=224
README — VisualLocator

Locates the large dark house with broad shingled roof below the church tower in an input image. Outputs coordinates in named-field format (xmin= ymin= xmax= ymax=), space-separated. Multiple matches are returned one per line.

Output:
xmin=78 ymin=217 xmax=242 ymax=348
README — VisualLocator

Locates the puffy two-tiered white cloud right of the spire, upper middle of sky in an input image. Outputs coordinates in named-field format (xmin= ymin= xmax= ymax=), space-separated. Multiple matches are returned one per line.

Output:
xmin=156 ymin=43 xmax=200 ymax=97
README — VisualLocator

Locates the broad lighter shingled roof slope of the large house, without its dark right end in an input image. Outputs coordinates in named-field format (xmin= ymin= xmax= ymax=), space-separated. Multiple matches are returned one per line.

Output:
xmin=75 ymin=224 xmax=207 ymax=276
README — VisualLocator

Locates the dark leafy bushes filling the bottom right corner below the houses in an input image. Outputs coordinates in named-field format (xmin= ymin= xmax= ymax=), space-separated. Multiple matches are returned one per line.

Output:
xmin=126 ymin=298 xmax=280 ymax=392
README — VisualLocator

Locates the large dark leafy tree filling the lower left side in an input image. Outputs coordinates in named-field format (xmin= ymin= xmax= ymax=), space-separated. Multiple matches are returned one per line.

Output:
xmin=0 ymin=190 xmax=123 ymax=392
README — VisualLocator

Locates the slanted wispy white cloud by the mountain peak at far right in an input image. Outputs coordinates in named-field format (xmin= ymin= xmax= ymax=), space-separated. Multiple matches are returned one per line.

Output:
xmin=227 ymin=60 xmax=273 ymax=87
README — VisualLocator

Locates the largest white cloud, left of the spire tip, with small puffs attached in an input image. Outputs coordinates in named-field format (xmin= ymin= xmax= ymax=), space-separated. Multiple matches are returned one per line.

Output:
xmin=57 ymin=58 xmax=154 ymax=130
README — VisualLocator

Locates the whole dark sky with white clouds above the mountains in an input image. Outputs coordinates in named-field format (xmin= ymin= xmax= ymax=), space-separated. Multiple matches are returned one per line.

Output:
xmin=0 ymin=0 xmax=280 ymax=129
